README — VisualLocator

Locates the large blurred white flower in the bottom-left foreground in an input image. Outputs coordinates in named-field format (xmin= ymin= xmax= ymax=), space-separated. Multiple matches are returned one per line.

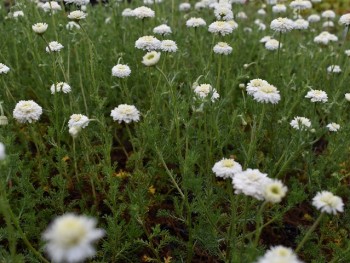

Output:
xmin=43 ymin=214 xmax=105 ymax=263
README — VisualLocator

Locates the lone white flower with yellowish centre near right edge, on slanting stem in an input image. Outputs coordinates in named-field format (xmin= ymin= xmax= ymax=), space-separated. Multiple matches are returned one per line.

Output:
xmin=312 ymin=191 xmax=344 ymax=215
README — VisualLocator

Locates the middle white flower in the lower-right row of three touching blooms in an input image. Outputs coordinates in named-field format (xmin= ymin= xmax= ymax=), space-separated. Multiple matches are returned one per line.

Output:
xmin=232 ymin=168 xmax=271 ymax=200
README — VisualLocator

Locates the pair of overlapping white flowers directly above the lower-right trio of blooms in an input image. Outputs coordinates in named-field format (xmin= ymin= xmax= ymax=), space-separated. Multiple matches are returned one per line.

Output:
xmin=246 ymin=79 xmax=281 ymax=104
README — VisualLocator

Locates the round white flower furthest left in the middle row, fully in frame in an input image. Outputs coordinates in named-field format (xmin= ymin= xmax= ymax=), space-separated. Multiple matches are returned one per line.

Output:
xmin=13 ymin=100 xmax=43 ymax=123
